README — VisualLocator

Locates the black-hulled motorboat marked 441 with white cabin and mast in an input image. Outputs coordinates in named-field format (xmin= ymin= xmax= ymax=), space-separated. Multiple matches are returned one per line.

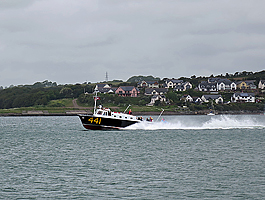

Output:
xmin=79 ymin=89 xmax=143 ymax=130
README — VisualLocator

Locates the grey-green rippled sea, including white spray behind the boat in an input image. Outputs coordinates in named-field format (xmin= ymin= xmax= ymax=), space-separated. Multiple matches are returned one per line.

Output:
xmin=0 ymin=115 xmax=265 ymax=200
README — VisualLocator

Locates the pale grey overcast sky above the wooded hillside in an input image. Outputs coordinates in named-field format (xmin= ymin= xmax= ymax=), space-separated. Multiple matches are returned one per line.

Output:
xmin=0 ymin=0 xmax=265 ymax=86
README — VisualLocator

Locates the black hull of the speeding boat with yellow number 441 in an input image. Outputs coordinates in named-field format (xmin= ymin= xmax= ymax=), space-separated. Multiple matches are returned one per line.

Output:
xmin=79 ymin=115 xmax=140 ymax=130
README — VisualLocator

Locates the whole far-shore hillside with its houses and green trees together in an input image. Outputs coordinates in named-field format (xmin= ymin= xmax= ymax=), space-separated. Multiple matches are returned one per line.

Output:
xmin=0 ymin=70 xmax=265 ymax=115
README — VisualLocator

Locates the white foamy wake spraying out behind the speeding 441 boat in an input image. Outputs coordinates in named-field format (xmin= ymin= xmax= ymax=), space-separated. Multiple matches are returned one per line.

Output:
xmin=126 ymin=115 xmax=265 ymax=130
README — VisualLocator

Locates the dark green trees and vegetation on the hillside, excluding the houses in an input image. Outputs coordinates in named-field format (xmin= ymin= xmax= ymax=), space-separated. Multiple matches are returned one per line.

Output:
xmin=0 ymin=70 xmax=265 ymax=111
